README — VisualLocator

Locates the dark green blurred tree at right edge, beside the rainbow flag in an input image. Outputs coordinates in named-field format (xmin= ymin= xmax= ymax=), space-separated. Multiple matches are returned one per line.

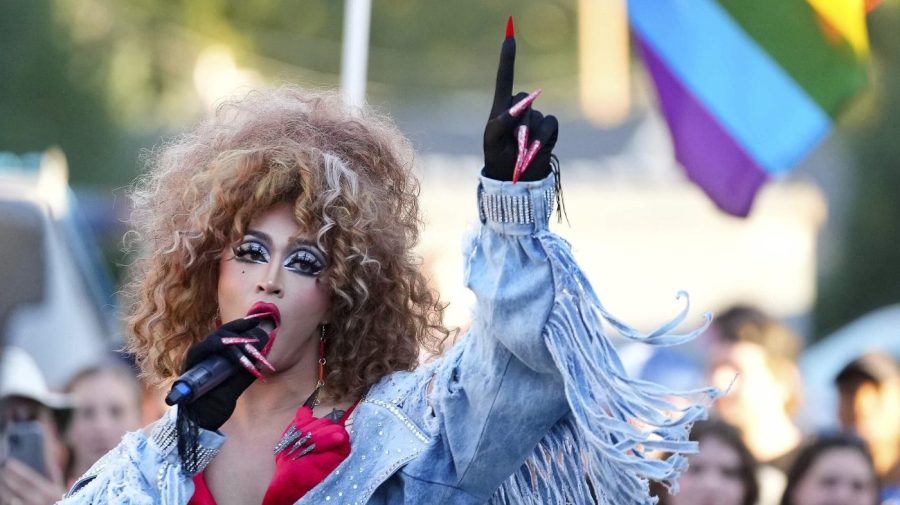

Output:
xmin=815 ymin=2 xmax=900 ymax=336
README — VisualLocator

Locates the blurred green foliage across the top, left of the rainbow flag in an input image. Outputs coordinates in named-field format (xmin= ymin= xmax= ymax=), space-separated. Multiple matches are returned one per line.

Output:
xmin=0 ymin=0 xmax=576 ymax=186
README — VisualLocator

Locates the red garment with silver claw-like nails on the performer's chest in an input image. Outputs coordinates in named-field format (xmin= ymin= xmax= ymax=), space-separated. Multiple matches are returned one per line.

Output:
xmin=188 ymin=403 xmax=356 ymax=505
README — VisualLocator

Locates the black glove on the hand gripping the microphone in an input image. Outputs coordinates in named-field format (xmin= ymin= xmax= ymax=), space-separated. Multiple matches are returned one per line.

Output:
xmin=179 ymin=317 xmax=269 ymax=431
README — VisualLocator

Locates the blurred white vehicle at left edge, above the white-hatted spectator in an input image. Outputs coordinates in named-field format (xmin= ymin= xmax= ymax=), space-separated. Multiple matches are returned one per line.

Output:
xmin=0 ymin=149 xmax=120 ymax=388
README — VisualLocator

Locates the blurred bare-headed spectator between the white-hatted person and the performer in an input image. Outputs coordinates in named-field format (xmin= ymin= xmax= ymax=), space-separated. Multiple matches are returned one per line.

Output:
xmin=65 ymin=362 xmax=142 ymax=486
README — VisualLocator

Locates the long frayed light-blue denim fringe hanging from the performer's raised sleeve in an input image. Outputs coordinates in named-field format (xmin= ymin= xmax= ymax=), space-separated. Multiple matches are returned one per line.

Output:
xmin=491 ymin=234 xmax=720 ymax=505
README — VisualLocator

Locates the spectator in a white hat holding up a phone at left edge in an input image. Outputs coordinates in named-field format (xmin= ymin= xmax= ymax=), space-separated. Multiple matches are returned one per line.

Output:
xmin=0 ymin=347 xmax=73 ymax=505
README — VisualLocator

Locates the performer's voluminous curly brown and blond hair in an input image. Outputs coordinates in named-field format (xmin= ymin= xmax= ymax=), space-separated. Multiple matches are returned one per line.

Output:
xmin=125 ymin=86 xmax=447 ymax=400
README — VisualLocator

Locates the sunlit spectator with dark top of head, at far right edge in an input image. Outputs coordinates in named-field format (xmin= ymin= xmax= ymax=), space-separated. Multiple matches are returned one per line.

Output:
xmin=834 ymin=352 xmax=900 ymax=505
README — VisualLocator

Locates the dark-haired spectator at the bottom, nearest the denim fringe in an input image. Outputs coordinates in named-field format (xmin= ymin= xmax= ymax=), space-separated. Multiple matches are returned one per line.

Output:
xmin=656 ymin=420 xmax=759 ymax=505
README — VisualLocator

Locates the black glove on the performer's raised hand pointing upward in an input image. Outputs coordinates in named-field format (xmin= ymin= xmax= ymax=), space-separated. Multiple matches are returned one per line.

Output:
xmin=484 ymin=29 xmax=559 ymax=181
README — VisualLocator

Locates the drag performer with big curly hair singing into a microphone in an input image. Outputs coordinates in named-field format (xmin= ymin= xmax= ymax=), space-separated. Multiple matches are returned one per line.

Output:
xmin=63 ymin=19 xmax=715 ymax=505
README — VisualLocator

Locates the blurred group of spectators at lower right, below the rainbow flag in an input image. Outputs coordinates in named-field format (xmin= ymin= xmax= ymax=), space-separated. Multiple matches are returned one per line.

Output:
xmin=654 ymin=306 xmax=900 ymax=505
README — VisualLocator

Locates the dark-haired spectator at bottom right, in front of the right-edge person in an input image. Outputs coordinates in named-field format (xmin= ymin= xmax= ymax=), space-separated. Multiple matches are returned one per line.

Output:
xmin=781 ymin=435 xmax=878 ymax=505
